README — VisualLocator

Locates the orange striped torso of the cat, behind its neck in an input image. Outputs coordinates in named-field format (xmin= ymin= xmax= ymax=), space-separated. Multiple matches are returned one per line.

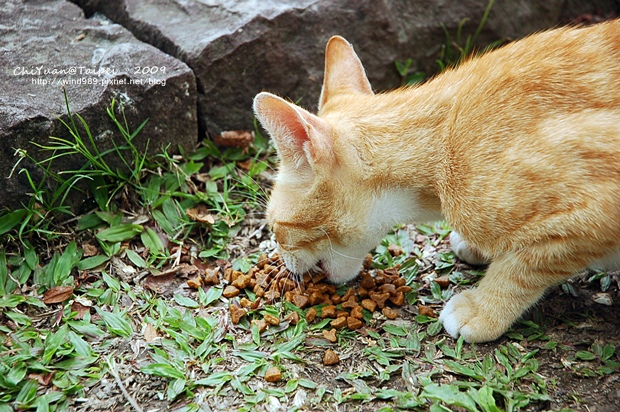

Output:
xmin=440 ymin=20 xmax=620 ymax=253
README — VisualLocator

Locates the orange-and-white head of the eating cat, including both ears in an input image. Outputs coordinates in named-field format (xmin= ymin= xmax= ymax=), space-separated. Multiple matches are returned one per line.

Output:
xmin=254 ymin=37 xmax=385 ymax=283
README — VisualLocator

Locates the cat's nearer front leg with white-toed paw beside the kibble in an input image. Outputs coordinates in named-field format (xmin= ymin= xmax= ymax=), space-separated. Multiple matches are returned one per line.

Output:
xmin=439 ymin=254 xmax=570 ymax=342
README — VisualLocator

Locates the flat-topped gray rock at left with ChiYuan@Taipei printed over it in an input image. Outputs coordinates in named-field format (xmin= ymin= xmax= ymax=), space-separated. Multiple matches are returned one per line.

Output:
xmin=0 ymin=0 xmax=198 ymax=208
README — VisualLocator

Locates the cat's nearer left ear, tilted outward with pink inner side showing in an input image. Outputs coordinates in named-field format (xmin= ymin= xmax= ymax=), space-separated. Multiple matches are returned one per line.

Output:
xmin=254 ymin=92 xmax=333 ymax=170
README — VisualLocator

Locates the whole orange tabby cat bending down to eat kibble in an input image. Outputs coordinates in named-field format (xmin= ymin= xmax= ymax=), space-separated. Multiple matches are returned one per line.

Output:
xmin=254 ymin=21 xmax=620 ymax=342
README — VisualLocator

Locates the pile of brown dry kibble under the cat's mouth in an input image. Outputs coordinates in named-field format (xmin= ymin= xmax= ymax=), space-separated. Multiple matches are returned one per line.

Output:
xmin=218 ymin=251 xmax=411 ymax=328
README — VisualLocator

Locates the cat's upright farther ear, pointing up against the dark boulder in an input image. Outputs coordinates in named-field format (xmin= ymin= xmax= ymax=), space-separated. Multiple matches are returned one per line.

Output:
xmin=319 ymin=36 xmax=374 ymax=110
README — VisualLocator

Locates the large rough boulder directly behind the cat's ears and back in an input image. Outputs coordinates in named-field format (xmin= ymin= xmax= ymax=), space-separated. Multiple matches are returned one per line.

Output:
xmin=73 ymin=0 xmax=617 ymax=133
